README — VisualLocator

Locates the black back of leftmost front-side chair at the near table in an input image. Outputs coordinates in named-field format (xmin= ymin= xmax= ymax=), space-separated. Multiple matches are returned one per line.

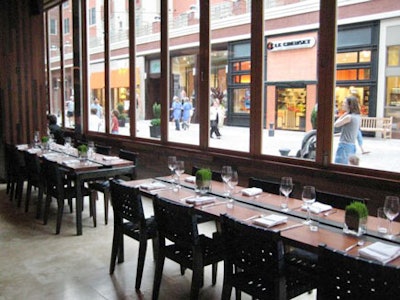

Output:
xmin=110 ymin=179 xmax=145 ymax=225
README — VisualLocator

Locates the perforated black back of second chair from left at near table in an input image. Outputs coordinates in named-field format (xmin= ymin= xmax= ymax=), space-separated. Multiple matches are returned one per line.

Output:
xmin=153 ymin=195 xmax=199 ymax=248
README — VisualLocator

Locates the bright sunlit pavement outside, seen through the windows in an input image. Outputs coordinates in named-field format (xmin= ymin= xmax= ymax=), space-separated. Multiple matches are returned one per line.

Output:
xmin=120 ymin=121 xmax=400 ymax=172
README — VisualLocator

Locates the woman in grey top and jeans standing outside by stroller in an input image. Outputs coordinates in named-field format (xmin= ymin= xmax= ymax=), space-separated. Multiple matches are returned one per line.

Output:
xmin=334 ymin=96 xmax=361 ymax=165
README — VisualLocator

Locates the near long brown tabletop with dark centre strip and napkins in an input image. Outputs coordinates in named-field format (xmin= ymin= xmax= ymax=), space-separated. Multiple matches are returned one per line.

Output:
xmin=125 ymin=174 xmax=400 ymax=266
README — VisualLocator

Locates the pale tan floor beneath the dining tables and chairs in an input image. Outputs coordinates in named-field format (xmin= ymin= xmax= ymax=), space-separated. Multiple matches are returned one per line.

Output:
xmin=0 ymin=184 xmax=315 ymax=300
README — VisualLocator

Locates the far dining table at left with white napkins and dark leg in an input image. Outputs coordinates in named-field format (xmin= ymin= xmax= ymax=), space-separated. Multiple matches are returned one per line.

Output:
xmin=17 ymin=144 xmax=136 ymax=235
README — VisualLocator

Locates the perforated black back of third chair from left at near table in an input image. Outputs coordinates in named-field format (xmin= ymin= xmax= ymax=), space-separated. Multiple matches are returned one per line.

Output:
xmin=221 ymin=214 xmax=284 ymax=276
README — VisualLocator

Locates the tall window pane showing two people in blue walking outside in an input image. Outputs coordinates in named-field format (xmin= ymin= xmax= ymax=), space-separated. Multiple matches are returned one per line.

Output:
xmin=168 ymin=0 xmax=200 ymax=145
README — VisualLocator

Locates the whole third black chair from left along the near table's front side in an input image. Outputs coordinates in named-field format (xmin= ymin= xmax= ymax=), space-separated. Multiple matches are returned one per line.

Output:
xmin=221 ymin=215 xmax=316 ymax=299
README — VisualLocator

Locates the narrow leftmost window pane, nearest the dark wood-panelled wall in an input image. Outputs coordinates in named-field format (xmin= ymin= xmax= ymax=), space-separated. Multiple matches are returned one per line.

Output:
xmin=47 ymin=6 xmax=64 ymax=127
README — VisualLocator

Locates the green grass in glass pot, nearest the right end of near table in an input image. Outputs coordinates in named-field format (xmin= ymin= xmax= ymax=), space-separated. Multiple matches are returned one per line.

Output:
xmin=343 ymin=201 xmax=368 ymax=236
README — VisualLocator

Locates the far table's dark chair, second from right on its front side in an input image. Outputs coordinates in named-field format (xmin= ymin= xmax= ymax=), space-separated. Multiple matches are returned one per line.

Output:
xmin=24 ymin=151 xmax=46 ymax=218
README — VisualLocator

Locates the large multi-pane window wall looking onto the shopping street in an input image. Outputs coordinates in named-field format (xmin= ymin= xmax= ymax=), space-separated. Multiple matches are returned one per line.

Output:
xmin=47 ymin=0 xmax=400 ymax=172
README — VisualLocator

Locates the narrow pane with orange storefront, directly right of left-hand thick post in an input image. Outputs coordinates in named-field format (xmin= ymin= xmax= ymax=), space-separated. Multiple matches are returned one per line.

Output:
xmin=85 ymin=0 xmax=107 ymax=132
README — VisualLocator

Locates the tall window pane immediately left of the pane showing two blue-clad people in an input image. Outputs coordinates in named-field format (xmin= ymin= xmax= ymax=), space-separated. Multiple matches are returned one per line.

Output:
xmin=136 ymin=0 xmax=161 ymax=139
